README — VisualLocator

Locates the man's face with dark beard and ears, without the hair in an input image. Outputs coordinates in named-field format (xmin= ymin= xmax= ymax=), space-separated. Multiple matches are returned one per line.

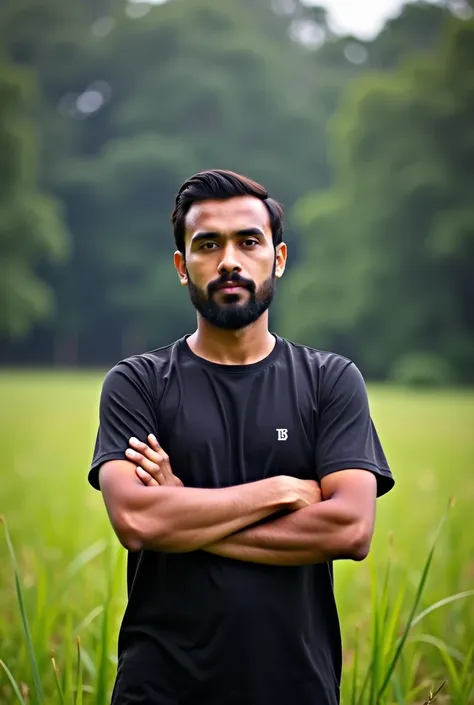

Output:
xmin=175 ymin=196 xmax=286 ymax=330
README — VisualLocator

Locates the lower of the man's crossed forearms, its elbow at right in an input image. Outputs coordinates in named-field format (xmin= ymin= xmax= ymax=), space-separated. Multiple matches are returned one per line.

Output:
xmin=204 ymin=498 xmax=373 ymax=566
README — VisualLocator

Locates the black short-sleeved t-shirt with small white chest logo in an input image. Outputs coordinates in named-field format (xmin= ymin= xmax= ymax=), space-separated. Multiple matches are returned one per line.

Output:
xmin=89 ymin=336 xmax=394 ymax=705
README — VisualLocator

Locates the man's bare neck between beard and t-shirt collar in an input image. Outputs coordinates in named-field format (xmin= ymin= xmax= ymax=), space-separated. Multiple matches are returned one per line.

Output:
xmin=187 ymin=313 xmax=275 ymax=365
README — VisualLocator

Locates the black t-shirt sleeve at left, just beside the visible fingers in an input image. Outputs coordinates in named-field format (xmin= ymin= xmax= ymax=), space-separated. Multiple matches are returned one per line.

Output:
xmin=88 ymin=358 xmax=157 ymax=490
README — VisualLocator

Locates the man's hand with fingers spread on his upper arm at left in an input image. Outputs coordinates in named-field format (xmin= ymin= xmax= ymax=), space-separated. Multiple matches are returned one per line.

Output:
xmin=125 ymin=434 xmax=183 ymax=487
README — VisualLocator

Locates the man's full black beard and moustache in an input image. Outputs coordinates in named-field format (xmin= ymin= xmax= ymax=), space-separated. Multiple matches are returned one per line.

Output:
xmin=186 ymin=263 xmax=276 ymax=330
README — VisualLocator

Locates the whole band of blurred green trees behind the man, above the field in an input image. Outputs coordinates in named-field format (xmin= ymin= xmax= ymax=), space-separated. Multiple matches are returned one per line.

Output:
xmin=0 ymin=0 xmax=473 ymax=378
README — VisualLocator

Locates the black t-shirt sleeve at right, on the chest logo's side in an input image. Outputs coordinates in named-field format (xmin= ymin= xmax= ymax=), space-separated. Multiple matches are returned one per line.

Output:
xmin=316 ymin=362 xmax=395 ymax=497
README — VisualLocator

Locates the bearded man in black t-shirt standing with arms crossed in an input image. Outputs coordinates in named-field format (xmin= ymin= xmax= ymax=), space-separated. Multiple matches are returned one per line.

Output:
xmin=89 ymin=170 xmax=394 ymax=705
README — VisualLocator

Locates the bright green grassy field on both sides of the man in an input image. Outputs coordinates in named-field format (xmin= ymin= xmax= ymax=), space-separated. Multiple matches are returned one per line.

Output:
xmin=0 ymin=372 xmax=474 ymax=705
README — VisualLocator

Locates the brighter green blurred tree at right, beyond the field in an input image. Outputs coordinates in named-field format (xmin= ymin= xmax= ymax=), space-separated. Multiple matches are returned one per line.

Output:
xmin=284 ymin=20 xmax=474 ymax=382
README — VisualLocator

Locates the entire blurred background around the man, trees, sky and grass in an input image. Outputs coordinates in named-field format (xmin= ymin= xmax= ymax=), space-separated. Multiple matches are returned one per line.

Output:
xmin=0 ymin=0 xmax=474 ymax=705
